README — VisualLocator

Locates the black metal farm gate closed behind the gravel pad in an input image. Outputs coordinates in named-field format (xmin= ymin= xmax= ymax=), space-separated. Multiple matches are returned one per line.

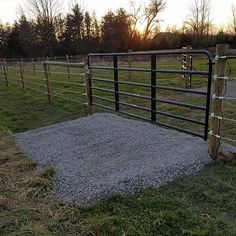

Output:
xmin=88 ymin=50 xmax=213 ymax=140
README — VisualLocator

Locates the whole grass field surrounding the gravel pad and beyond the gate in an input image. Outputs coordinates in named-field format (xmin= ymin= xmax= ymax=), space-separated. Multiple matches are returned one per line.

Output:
xmin=0 ymin=54 xmax=236 ymax=236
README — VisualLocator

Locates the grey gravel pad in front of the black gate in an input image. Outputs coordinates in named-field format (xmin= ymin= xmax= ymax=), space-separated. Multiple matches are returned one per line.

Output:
xmin=15 ymin=113 xmax=210 ymax=205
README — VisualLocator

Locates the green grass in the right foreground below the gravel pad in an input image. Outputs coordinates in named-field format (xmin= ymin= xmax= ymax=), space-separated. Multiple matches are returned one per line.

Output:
xmin=79 ymin=163 xmax=236 ymax=235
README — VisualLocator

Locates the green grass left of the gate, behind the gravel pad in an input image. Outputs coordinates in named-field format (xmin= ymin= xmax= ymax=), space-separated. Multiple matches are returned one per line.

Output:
xmin=0 ymin=64 xmax=86 ymax=132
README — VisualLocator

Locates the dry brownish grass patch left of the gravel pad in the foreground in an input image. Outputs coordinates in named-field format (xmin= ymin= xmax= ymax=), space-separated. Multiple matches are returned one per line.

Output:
xmin=0 ymin=133 xmax=83 ymax=236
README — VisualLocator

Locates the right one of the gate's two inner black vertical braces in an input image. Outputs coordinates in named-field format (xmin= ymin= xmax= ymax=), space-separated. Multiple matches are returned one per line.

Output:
xmin=151 ymin=54 xmax=156 ymax=122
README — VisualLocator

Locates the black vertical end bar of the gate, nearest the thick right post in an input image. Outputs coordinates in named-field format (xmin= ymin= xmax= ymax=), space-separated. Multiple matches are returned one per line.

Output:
xmin=204 ymin=61 xmax=213 ymax=141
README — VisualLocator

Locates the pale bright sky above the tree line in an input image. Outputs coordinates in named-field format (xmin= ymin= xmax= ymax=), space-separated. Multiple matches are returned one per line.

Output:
xmin=0 ymin=0 xmax=236 ymax=30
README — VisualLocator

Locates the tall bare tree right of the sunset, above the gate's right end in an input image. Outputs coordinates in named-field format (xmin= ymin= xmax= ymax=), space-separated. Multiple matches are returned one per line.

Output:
xmin=185 ymin=0 xmax=211 ymax=36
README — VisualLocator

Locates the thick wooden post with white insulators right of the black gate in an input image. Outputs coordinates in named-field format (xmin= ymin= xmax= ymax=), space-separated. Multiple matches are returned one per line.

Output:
xmin=209 ymin=44 xmax=228 ymax=159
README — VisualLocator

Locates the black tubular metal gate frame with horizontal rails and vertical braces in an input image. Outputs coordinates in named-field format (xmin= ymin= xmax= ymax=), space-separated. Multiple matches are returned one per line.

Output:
xmin=87 ymin=50 xmax=214 ymax=140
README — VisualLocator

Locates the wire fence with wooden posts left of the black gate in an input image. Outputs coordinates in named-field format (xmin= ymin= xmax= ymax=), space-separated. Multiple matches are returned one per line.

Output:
xmin=0 ymin=60 xmax=85 ymax=109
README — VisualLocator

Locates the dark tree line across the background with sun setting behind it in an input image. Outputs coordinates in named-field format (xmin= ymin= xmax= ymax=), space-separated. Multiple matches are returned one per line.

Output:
xmin=0 ymin=0 xmax=236 ymax=57
